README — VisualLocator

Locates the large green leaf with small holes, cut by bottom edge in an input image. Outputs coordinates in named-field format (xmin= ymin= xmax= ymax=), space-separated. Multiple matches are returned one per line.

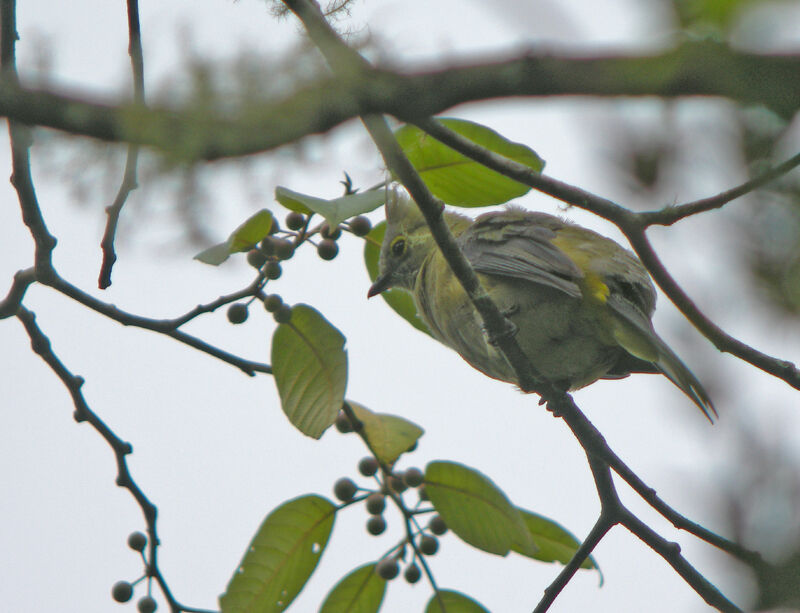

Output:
xmin=219 ymin=495 xmax=336 ymax=613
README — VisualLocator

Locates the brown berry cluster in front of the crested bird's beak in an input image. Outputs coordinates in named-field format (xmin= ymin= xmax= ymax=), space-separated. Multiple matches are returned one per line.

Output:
xmin=227 ymin=211 xmax=372 ymax=324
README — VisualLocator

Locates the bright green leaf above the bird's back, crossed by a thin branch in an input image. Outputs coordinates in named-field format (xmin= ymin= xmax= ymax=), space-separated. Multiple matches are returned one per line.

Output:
xmin=395 ymin=119 xmax=544 ymax=207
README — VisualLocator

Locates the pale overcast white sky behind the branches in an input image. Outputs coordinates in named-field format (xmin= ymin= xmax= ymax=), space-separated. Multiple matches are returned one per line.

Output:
xmin=0 ymin=0 xmax=800 ymax=613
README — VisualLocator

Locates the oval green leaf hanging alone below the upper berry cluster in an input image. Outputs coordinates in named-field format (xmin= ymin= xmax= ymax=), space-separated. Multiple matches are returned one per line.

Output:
xmin=272 ymin=304 xmax=347 ymax=438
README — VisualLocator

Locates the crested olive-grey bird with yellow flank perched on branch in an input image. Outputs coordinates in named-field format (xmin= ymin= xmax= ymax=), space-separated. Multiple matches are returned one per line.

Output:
xmin=368 ymin=191 xmax=716 ymax=420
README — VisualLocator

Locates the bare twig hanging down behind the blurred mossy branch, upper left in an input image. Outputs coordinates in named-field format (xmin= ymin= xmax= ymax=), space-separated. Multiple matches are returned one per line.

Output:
xmin=97 ymin=0 xmax=144 ymax=289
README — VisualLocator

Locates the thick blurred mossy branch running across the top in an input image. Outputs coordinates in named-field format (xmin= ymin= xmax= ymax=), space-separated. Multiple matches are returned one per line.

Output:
xmin=0 ymin=43 xmax=800 ymax=160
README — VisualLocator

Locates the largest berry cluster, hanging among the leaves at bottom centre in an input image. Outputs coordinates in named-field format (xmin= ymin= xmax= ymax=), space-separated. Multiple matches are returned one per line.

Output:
xmin=333 ymin=412 xmax=447 ymax=584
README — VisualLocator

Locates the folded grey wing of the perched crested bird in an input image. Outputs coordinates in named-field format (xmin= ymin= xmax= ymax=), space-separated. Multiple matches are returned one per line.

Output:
xmin=459 ymin=209 xmax=583 ymax=298
